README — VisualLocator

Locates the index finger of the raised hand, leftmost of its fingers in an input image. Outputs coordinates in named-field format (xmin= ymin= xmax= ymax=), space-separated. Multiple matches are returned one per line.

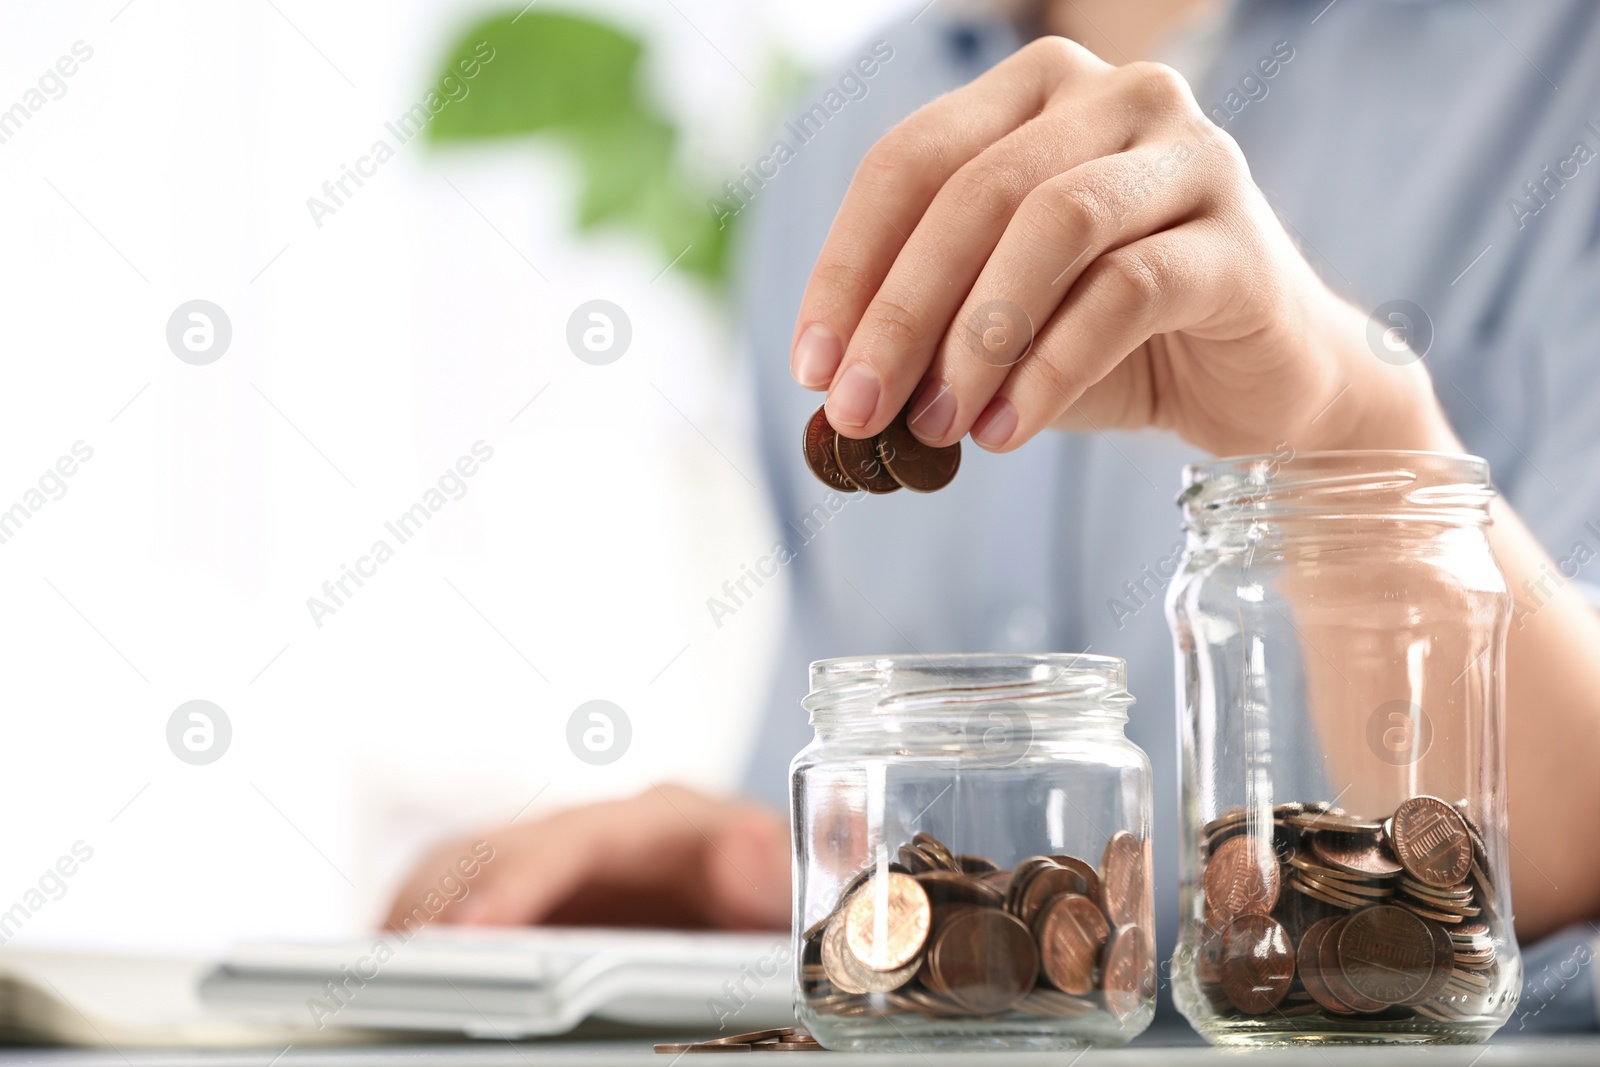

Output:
xmin=790 ymin=38 xmax=1106 ymax=399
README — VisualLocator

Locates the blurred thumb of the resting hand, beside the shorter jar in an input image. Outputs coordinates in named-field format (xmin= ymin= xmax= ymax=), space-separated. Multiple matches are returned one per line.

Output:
xmin=704 ymin=808 xmax=789 ymax=929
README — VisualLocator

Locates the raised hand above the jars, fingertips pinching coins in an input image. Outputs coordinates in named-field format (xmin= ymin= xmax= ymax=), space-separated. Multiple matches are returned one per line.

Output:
xmin=790 ymin=38 xmax=1453 ymax=454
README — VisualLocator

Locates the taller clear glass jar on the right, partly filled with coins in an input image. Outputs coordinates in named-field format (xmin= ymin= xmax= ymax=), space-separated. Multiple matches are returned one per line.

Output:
xmin=1166 ymin=451 xmax=1522 ymax=1045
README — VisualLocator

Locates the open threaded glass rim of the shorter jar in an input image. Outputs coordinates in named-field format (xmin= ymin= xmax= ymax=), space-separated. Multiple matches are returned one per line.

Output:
xmin=800 ymin=653 xmax=1133 ymax=725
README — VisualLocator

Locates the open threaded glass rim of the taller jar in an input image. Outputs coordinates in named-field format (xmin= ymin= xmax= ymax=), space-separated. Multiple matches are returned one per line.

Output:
xmin=1178 ymin=450 xmax=1496 ymax=526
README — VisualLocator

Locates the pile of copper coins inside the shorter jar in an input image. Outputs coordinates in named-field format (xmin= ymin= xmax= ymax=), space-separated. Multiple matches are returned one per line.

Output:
xmin=800 ymin=830 xmax=1155 ymax=1021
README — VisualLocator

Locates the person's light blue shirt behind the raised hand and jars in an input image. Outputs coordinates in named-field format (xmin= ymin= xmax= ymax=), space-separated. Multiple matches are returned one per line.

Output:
xmin=741 ymin=0 xmax=1600 ymax=1029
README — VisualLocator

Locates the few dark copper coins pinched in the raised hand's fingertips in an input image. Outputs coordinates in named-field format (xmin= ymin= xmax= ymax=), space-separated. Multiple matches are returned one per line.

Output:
xmin=802 ymin=408 xmax=962 ymax=494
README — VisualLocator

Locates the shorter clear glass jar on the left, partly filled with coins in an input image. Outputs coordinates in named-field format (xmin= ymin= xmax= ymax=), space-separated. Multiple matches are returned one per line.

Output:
xmin=790 ymin=654 xmax=1155 ymax=1051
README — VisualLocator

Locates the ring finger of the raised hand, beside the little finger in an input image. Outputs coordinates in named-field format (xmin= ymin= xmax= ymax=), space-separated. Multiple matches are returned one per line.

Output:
xmin=910 ymin=144 xmax=1210 ymax=446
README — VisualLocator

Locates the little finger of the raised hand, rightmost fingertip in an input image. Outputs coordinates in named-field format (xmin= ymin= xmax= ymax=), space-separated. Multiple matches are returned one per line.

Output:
xmin=973 ymin=221 xmax=1222 ymax=451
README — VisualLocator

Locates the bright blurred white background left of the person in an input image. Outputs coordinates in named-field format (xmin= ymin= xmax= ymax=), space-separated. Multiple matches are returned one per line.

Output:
xmin=0 ymin=0 xmax=921 ymax=952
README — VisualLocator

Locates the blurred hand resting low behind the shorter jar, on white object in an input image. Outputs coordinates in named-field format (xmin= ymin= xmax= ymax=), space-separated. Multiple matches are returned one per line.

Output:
xmin=386 ymin=785 xmax=789 ymax=929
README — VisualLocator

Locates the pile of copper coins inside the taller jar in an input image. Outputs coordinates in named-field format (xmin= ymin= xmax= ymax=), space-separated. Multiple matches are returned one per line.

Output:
xmin=1195 ymin=797 xmax=1507 ymax=1021
